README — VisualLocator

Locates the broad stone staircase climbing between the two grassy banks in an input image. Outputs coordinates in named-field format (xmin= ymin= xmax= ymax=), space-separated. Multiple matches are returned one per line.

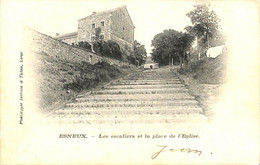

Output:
xmin=48 ymin=68 xmax=207 ymax=124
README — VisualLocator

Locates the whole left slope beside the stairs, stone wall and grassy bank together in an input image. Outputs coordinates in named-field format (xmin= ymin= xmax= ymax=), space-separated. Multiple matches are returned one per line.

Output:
xmin=23 ymin=29 xmax=135 ymax=112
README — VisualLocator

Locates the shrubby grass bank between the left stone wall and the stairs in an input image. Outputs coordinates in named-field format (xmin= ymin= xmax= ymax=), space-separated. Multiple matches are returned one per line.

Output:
xmin=35 ymin=52 xmax=136 ymax=113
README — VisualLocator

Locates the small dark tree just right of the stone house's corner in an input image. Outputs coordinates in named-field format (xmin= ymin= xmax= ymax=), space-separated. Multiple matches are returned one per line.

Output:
xmin=134 ymin=40 xmax=147 ymax=65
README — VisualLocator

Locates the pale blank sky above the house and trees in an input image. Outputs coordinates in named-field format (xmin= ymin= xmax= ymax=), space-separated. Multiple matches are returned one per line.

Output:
xmin=1 ymin=0 xmax=250 ymax=54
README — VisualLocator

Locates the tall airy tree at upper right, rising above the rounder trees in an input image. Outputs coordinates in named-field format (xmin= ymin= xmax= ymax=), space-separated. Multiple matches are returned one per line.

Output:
xmin=185 ymin=4 xmax=220 ymax=48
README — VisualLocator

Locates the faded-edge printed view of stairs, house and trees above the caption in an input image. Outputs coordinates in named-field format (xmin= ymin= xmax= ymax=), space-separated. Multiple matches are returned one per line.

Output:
xmin=23 ymin=2 xmax=225 ymax=125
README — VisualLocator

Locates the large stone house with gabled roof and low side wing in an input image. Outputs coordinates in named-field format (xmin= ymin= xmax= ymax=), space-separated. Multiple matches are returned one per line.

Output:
xmin=56 ymin=6 xmax=135 ymax=50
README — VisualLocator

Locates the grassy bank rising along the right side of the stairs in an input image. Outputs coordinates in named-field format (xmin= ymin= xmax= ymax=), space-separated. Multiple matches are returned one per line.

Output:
xmin=173 ymin=55 xmax=226 ymax=119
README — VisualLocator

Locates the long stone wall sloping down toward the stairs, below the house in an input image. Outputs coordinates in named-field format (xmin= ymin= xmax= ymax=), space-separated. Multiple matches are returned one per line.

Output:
xmin=23 ymin=28 xmax=129 ymax=66
